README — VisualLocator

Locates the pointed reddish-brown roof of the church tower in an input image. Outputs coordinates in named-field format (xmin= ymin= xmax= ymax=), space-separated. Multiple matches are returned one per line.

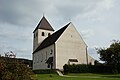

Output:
xmin=33 ymin=16 xmax=54 ymax=33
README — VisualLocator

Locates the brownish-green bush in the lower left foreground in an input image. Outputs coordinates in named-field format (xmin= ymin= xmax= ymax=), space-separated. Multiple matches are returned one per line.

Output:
xmin=0 ymin=58 xmax=33 ymax=80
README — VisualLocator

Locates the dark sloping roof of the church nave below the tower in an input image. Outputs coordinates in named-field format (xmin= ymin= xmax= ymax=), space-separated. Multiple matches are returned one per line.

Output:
xmin=33 ymin=23 xmax=70 ymax=53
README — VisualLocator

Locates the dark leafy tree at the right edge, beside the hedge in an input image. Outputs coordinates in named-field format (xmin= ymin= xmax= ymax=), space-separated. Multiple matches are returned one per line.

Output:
xmin=97 ymin=40 xmax=120 ymax=73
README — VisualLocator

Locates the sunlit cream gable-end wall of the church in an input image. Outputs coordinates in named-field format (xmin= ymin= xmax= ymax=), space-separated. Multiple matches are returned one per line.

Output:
xmin=56 ymin=24 xmax=87 ymax=69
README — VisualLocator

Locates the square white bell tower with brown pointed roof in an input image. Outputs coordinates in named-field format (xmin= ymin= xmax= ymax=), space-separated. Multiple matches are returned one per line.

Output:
xmin=33 ymin=16 xmax=54 ymax=51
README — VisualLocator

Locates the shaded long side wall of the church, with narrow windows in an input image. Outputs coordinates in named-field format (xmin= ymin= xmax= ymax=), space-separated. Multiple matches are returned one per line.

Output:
xmin=33 ymin=44 xmax=55 ymax=70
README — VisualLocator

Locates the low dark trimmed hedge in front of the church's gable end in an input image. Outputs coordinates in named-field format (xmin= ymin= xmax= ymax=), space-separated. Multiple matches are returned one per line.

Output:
xmin=63 ymin=64 xmax=113 ymax=74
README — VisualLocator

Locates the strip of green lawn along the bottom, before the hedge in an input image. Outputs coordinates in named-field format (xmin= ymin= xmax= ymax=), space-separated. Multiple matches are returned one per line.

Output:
xmin=35 ymin=73 xmax=120 ymax=80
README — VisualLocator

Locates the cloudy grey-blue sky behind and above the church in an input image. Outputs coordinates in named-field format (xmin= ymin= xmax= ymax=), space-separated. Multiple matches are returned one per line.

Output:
xmin=0 ymin=0 xmax=120 ymax=60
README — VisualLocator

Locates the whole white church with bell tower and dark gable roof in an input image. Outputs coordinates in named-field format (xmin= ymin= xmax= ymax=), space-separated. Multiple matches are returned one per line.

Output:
xmin=33 ymin=16 xmax=94 ymax=70
